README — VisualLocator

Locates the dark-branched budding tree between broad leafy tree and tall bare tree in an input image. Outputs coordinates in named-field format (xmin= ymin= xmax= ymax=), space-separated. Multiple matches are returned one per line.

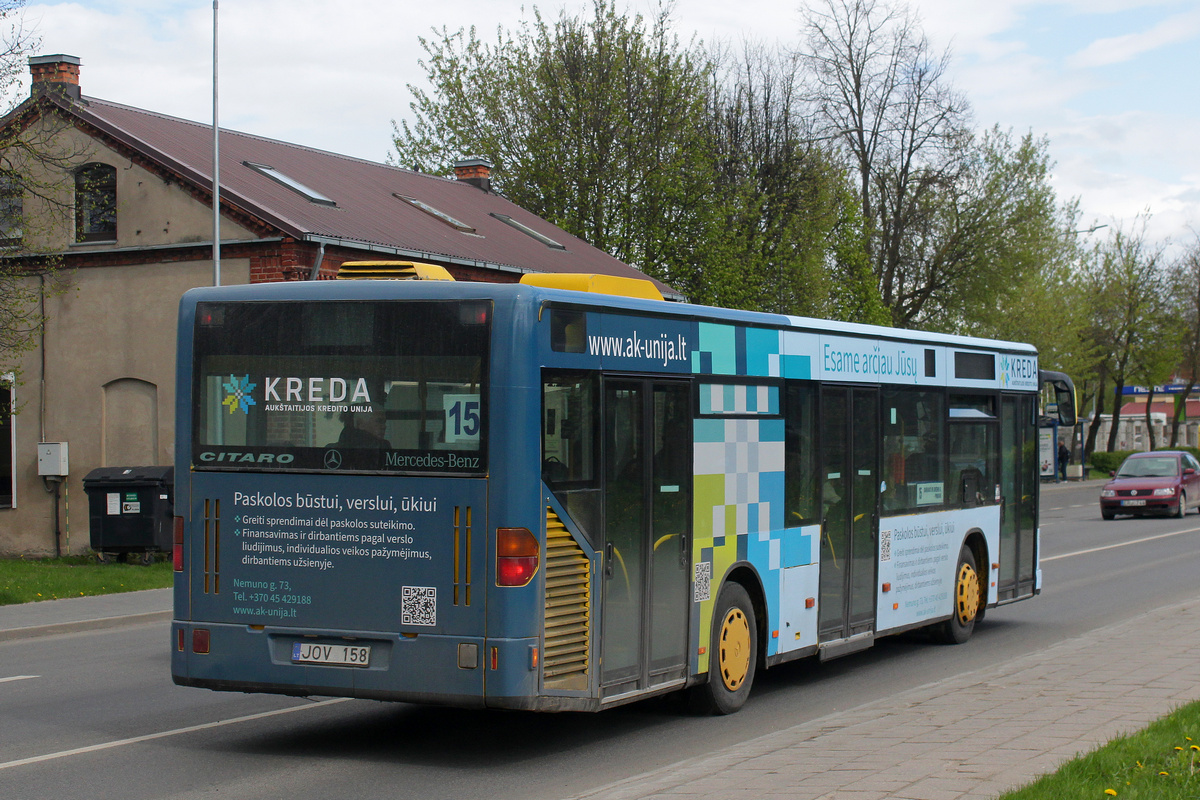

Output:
xmin=701 ymin=39 xmax=888 ymax=323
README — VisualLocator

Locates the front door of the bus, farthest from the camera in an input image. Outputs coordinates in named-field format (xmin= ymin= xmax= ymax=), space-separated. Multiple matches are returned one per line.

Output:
xmin=997 ymin=395 xmax=1040 ymax=602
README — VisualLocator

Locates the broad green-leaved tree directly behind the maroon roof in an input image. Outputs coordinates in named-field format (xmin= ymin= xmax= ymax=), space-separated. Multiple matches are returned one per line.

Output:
xmin=395 ymin=0 xmax=721 ymax=291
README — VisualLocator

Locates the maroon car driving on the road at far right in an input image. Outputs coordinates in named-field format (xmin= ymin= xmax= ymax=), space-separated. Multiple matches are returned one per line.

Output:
xmin=1100 ymin=450 xmax=1200 ymax=519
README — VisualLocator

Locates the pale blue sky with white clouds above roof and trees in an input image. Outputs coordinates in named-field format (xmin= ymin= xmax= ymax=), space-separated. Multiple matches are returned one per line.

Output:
xmin=11 ymin=0 xmax=1200 ymax=249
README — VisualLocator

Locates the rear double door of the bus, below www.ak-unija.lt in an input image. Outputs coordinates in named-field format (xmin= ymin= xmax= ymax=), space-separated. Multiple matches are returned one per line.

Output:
xmin=600 ymin=379 xmax=692 ymax=697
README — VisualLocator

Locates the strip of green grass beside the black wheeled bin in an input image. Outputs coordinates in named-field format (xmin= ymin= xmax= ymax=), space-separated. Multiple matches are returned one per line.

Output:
xmin=0 ymin=555 xmax=174 ymax=606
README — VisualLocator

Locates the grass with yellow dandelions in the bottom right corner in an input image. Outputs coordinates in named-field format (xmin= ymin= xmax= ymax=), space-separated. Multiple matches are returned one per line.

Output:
xmin=1000 ymin=703 xmax=1200 ymax=800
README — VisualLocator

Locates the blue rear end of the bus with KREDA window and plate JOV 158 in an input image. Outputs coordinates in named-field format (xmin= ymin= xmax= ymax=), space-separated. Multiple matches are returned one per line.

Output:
xmin=173 ymin=295 xmax=539 ymax=706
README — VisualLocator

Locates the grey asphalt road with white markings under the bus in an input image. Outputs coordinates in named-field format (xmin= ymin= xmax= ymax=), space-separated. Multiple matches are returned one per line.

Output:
xmin=0 ymin=483 xmax=1200 ymax=800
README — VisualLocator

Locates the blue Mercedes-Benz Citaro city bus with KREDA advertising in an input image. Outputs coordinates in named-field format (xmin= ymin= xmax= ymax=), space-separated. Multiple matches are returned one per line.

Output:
xmin=172 ymin=267 xmax=1074 ymax=714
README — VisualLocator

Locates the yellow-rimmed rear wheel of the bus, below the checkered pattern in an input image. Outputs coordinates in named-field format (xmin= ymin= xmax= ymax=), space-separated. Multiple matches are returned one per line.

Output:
xmin=690 ymin=583 xmax=758 ymax=714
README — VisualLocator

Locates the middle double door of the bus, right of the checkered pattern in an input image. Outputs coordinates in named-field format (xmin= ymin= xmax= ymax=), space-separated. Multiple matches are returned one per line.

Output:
xmin=817 ymin=386 xmax=880 ymax=657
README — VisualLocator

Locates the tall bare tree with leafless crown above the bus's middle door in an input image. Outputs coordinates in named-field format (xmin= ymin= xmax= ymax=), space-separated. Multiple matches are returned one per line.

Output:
xmin=802 ymin=0 xmax=972 ymax=325
